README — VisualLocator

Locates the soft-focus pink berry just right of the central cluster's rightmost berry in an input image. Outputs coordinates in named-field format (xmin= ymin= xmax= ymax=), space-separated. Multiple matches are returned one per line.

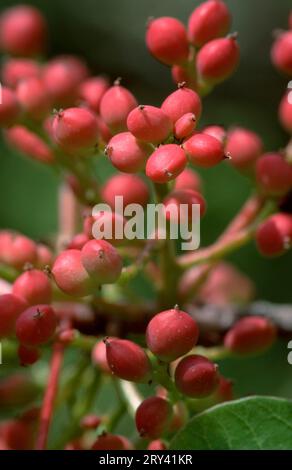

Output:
xmin=225 ymin=127 xmax=263 ymax=170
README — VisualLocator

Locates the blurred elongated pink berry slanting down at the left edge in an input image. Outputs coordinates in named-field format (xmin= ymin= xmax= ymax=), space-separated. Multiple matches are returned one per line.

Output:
xmin=5 ymin=126 xmax=55 ymax=165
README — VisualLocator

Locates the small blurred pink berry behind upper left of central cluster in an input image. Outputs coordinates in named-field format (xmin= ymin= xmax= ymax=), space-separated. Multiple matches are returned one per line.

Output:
xmin=79 ymin=77 xmax=109 ymax=113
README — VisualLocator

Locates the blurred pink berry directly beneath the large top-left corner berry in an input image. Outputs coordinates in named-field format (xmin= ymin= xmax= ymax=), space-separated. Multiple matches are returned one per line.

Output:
xmin=2 ymin=58 xmax=41 ymax=88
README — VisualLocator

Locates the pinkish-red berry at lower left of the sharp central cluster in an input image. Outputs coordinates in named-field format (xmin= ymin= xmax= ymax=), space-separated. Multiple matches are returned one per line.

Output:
xmin=106 ymin=131 xmax=151 ymax=173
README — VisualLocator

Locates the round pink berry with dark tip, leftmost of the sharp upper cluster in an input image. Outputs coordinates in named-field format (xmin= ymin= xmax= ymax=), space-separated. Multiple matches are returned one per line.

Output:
xmin=53 ymin=108 xmax=98 ymax=153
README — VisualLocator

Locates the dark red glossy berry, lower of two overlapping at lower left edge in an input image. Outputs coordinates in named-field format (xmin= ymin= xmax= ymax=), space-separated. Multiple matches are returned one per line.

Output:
xmin=16 ymin=304 xmax=57 ymax=347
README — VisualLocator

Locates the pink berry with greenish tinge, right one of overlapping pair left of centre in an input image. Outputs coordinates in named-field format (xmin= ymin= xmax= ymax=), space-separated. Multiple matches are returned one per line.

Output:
xmin=81 ymin=240 xmax=123 ymax=284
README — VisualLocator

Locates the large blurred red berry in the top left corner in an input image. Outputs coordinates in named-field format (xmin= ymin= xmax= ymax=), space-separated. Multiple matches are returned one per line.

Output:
xmin=0 ymin=5 xmax=47 ymax=56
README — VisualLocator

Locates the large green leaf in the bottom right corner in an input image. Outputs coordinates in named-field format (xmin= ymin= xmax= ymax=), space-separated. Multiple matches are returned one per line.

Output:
xmin=170 ymin=396 xmax=292 ymax=450
